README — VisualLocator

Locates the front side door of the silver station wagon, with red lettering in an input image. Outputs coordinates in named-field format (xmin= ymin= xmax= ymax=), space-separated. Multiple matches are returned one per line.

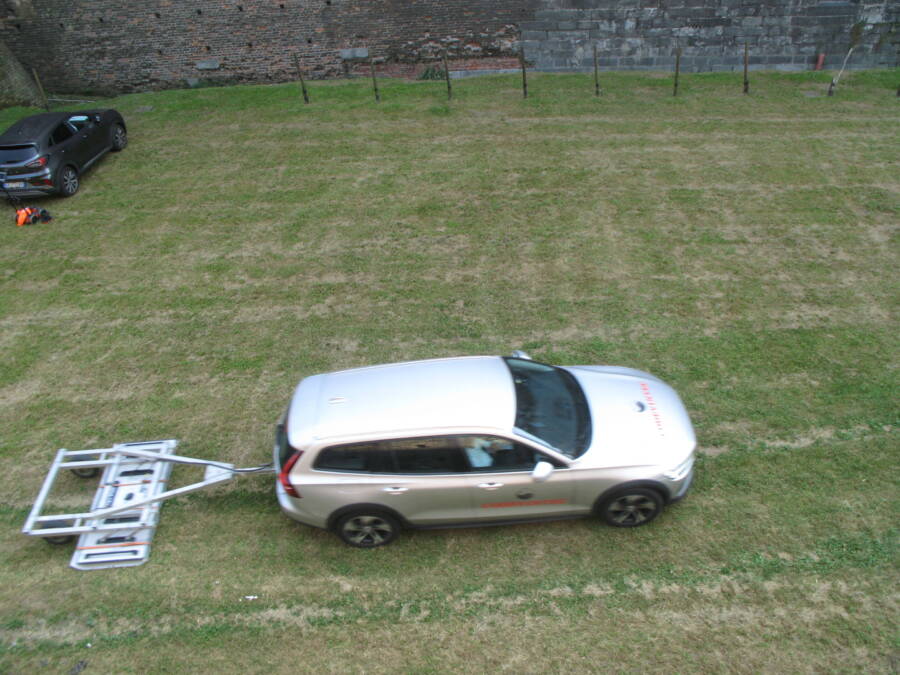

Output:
xmin=460 ymin=436 xmax=585 ymax=521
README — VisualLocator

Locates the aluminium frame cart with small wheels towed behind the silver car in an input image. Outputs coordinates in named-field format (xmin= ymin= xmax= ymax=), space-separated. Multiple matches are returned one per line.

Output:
xmin=22 ymin=439 xmax=258 ymax=570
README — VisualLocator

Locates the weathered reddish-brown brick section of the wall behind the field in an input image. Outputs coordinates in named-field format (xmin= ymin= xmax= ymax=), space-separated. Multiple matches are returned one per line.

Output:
xmin=0 ymin=0 xmax=540 ymax=93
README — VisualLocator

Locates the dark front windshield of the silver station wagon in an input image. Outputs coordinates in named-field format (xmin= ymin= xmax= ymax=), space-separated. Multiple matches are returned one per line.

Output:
xmin=504 ymin=358 xmax=591 ymax=459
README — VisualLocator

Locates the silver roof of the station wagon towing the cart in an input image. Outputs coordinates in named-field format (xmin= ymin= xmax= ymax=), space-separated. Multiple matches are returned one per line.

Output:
xmin=288 ymin=356 xmax=516 ymax=447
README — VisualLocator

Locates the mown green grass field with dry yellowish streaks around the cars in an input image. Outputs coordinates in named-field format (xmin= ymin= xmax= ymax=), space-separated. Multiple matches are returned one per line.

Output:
xmin=0 ymin=70 xmax=900 ymax=673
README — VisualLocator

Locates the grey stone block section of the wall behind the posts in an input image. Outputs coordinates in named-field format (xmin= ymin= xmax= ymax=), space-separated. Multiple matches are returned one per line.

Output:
xmin=522 ymin=0 xmax=900 ymax=72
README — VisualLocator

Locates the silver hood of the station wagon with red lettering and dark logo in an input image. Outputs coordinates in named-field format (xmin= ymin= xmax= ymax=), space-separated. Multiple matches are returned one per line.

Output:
xmin=565 ymin=366 xmax=697 ymax=467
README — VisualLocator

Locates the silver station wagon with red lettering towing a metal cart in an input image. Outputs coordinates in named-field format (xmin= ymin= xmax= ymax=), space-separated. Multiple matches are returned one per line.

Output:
xmin=275 ymin=352 xmax=696 ymax=548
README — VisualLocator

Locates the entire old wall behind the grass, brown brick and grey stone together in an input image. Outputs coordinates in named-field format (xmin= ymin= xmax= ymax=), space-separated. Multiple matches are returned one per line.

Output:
xmin=0 ymin=0 xmax=900 ymax=93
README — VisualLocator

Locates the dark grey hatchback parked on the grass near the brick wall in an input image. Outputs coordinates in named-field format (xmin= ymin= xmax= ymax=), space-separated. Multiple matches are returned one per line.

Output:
xmin=0 ymin=108 xmax=128 ymax=197
